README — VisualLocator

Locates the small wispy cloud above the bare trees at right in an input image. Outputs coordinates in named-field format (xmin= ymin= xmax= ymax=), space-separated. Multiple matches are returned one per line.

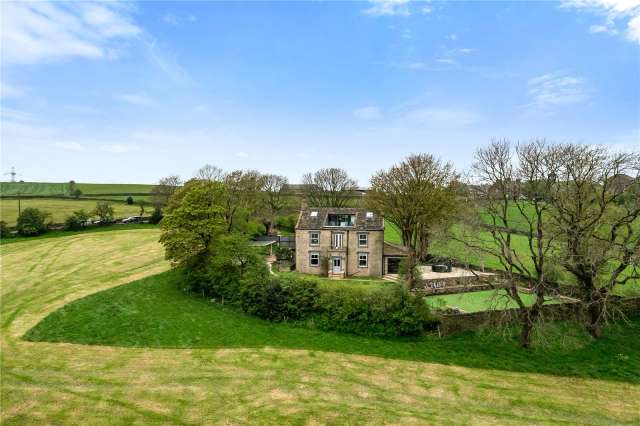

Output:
xmin=527 ymin=72 xmax=592 ymax=108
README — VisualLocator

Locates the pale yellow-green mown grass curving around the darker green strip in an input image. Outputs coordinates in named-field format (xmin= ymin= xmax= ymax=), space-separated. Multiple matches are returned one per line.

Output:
xmin=0 ymin=230 xmax=640 ymax=424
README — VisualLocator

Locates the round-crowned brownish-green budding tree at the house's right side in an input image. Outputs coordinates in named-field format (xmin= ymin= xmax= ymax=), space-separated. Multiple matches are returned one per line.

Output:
xmin=365 ymin=154 xmax=459 ymax=285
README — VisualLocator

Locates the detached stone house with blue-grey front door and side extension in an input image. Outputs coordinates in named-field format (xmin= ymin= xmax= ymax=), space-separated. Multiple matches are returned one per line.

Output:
xmin=296 ymin=208 xmax=406 ymax=278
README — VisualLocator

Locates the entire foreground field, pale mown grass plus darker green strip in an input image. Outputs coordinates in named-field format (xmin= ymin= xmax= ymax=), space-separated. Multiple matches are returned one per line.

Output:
xmin=0 ymin=229 xmax=640 ymax=424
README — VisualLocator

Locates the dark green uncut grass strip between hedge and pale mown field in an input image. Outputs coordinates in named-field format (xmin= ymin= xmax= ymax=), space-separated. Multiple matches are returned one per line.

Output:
xmin=25 ymin=270 xmax=640 ymax=383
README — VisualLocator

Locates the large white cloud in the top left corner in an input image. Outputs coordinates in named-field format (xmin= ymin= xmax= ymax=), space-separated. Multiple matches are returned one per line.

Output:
xmin=1 ymin=1 xmax=142 ymax=64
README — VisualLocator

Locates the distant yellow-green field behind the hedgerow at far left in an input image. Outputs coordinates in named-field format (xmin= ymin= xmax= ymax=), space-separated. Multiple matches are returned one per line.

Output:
xmin=0 ymin=198 xmax=142 ymax=226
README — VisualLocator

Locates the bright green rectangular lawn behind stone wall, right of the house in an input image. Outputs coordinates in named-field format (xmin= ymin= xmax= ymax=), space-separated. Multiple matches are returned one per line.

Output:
xmin=426 ymin=290 xmax=560 ymax=312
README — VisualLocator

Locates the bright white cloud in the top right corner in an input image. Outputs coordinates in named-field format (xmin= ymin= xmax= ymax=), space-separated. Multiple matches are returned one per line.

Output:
xmin=562 ymin=0 xmax=640 ymax=43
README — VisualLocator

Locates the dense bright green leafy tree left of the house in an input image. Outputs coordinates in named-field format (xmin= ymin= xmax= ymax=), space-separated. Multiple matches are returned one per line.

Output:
xmin=160 ymin=180 xmax=228 ymax=268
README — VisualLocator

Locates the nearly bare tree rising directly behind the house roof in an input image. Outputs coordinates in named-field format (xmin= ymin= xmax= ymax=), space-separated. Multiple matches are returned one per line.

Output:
xmin=302 ymin=168 xmax=357 ymax=207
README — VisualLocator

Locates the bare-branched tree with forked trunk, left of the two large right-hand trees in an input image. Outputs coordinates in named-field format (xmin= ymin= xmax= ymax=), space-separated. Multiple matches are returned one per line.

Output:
xmin=459 ymin=140 xmax=557 ymax=347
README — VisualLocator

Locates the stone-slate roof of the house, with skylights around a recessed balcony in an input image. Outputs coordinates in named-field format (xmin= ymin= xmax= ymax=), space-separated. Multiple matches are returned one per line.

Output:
xmin=296 ymin=207 xmax=384 ymax=231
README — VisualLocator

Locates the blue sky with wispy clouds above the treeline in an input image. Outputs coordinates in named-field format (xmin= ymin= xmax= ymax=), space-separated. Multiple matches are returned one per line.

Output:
xmin=0 ymin=0 xmax=640 ymax=186
